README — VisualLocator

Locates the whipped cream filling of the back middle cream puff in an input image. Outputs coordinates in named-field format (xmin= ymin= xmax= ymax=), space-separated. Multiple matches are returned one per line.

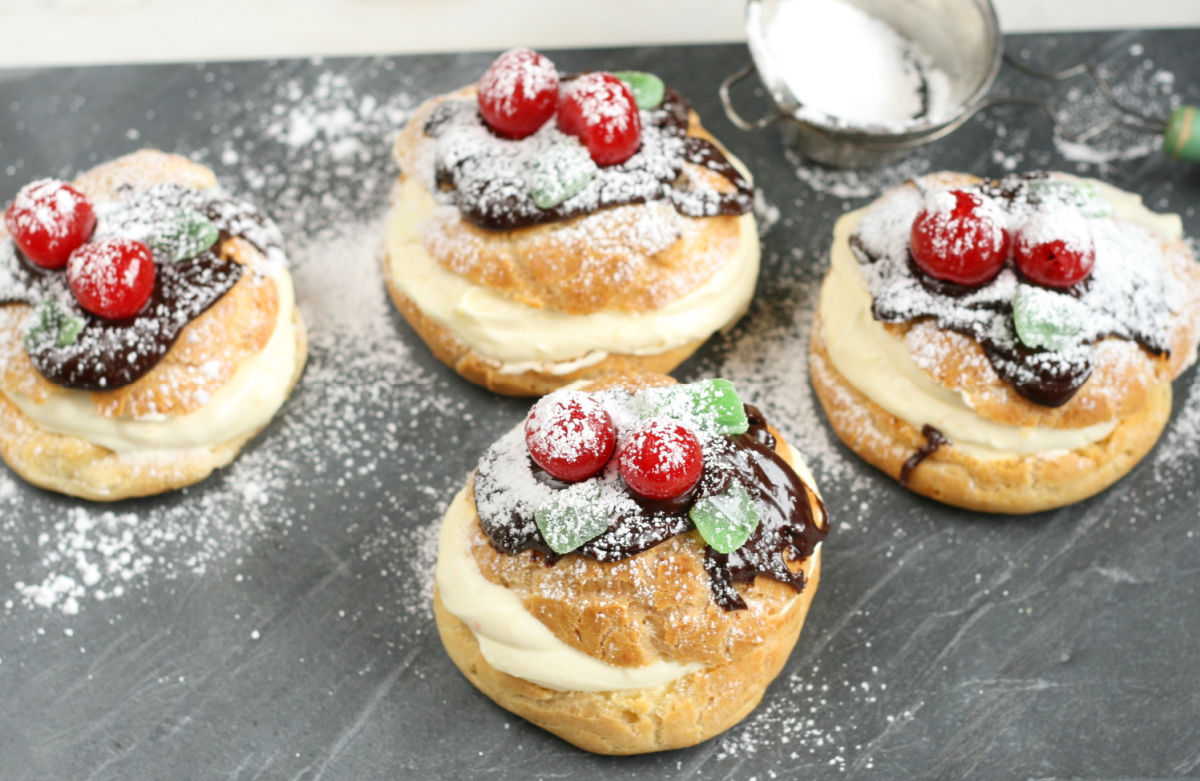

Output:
xmin=386 ymin=176 xmax=758 ymax=374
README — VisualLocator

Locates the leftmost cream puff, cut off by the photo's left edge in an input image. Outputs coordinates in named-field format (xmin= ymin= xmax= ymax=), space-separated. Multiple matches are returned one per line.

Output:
xmin=0 ymin=150 xmax=306 ymax=500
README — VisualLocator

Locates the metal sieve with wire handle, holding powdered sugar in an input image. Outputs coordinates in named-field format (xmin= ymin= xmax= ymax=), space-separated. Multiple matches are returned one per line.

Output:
xmin=720 ymin=0 xmax=1200 ymax=168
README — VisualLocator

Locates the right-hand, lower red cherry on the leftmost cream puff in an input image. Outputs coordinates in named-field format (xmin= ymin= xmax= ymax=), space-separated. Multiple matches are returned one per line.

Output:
xmin=67 ymin=239 xmax=156 ymax=320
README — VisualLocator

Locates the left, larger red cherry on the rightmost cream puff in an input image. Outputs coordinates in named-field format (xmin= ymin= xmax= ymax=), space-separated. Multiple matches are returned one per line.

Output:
xmin=910 ymin=190 xmax=1010 ymax=286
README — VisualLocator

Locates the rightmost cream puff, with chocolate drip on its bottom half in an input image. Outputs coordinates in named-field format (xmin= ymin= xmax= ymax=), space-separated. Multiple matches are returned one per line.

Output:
xmin=810 ymin=173 xmax=1200 ymax=512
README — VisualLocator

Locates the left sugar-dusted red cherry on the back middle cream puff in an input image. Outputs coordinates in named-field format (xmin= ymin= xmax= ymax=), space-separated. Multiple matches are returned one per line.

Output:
xmin=478 ymin=48 xmax=558 ymax=138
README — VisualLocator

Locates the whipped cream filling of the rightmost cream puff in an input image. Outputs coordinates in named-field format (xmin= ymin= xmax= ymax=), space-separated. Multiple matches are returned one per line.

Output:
xmin=818 ymin=181 xmax=1182 ymax=458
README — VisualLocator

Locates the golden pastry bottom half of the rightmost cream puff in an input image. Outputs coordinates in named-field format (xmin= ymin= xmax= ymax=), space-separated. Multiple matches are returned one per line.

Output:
xmin=809 ymin=314 xmax=1171 ymax=513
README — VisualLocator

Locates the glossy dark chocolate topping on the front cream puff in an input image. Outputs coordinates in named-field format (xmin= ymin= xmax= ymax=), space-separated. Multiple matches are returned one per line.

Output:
xmin=474 ymin=404 xmax=829 ymax=611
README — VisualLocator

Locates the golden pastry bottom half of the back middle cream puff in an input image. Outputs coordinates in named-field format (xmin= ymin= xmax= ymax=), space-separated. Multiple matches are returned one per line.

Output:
xmin=384 ymin=272 xmax=704 ymax=396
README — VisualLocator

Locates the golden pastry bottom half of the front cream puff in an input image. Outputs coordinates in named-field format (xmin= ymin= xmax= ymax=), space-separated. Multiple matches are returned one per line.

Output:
xmin=433 ymin=547 xmax=821 ymax=755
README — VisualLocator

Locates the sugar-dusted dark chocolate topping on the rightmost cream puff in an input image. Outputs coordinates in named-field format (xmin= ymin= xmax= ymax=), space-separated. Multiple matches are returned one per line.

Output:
xmin=850 ymin=173 xmax=1169 ymax=407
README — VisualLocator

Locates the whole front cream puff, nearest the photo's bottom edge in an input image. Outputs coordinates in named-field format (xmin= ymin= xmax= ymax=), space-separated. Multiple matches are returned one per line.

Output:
xmin=433 ymin=376 xmax=829 ymax=755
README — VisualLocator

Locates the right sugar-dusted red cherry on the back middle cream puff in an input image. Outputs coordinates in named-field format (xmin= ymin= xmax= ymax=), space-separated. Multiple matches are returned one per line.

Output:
xmin=558 ymin=72 xmax=642 ymax=166
